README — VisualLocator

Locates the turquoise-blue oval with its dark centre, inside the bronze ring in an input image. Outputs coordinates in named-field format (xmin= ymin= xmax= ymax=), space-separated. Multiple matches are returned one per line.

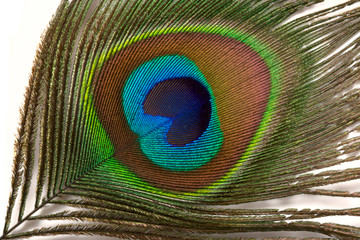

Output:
xmin=122 ymin=55 xmax=223 ymax=171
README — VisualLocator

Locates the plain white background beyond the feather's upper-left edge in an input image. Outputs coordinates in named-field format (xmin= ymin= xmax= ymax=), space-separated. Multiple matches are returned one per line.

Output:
xmin=0 ymin=0 xmax=354 ymax=235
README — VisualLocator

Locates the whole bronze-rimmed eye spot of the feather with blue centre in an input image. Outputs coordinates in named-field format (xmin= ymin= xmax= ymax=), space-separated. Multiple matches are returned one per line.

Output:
xmin=94 ymin=31 xmax=272 ymax=192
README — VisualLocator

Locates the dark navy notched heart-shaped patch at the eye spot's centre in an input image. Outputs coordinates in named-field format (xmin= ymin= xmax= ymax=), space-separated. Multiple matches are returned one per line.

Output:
xmin=143 ymin=78 xmax=211 ymax=146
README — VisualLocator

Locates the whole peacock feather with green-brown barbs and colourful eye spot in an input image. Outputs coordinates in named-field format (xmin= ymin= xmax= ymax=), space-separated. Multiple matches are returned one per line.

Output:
xmin=0 ymin=0 xmax=360 ymax=239
